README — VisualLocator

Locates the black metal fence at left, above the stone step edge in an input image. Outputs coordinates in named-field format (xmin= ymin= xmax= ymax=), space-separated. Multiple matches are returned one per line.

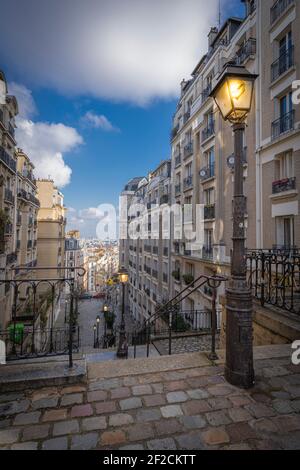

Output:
xmin=0 ymin=266 xmax=85 ymax=367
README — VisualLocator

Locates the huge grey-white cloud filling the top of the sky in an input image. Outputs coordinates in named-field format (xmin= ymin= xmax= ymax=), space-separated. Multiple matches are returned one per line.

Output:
xmin=0 ymin=0 xmax=218 ymax=105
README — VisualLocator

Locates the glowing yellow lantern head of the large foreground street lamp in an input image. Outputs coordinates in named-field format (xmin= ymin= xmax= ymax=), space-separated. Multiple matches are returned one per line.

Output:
xmin=211 ymin=66 xmax=257 ymax=123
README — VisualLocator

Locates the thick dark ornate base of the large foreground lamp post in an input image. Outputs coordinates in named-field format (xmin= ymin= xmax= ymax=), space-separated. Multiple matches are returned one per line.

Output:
xmin=225 ymin=279 xmax=254 ymax=389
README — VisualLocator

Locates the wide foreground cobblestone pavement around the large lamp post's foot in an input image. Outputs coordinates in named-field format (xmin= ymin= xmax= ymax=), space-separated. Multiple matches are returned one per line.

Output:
xmin=0 ymin=356 xmax=300 ymax=450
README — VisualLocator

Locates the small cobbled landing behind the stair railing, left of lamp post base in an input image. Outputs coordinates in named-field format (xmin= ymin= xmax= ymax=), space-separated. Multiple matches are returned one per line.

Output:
xmin=153 ymin=335 xmax=219 ymax=356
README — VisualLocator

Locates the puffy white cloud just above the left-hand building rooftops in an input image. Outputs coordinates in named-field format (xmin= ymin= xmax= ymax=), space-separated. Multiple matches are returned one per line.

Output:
xmin=9 ymin=83 xmax=83 ymax=187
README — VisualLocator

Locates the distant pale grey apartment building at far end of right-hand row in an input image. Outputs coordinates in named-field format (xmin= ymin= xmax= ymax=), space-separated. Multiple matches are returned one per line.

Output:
xmin=120 ymin=160 xmax=171 ymax=322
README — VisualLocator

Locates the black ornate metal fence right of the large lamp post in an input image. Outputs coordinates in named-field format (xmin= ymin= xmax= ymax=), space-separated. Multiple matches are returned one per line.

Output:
xmin=247 ymin=247 xmax=300 ymax=315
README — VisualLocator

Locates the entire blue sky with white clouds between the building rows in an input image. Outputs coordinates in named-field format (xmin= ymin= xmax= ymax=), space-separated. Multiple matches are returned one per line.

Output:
xmin=0 ymin=0 xmax=244 ymax=237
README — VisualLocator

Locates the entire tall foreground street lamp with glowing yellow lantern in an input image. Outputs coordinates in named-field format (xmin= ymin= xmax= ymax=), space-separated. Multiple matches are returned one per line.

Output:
xmin=211 ymin=63 xmax=257 ymax=389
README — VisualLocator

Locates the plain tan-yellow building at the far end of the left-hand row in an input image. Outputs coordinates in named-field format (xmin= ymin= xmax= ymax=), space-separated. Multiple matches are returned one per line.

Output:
xmin=36 ymin=179 xmax=66 ymax=279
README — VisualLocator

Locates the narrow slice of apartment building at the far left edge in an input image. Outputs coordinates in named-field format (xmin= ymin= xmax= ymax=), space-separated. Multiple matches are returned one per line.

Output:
xmin=0 ymin=71 xmax=18 ymax=328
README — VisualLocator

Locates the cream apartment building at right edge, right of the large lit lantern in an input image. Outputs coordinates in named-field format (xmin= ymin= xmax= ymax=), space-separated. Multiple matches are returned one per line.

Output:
xmin=257 ymin=0 xmax=300 ymax=248
